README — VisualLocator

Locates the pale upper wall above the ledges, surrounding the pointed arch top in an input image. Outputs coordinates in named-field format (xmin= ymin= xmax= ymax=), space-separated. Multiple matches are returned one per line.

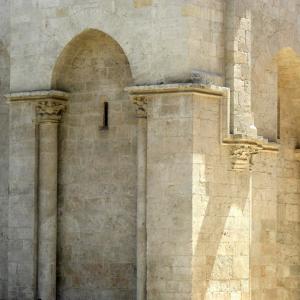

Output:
xmin=11 ymin=0 xmax=224 ymax=91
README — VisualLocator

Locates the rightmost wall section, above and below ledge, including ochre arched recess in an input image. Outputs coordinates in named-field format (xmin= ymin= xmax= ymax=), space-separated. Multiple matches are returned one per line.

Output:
xmin=249 ymin=0 xmax=300 ymax=299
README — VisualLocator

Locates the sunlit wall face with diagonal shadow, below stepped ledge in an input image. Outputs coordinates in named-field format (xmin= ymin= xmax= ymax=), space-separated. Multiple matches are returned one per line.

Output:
xmin=192 ymin=96 xmax=252 ymax=299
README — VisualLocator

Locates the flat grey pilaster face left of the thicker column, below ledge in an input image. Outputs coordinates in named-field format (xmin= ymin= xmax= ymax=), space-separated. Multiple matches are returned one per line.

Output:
xmin=8 ymin=100 xmax=37 ymax=300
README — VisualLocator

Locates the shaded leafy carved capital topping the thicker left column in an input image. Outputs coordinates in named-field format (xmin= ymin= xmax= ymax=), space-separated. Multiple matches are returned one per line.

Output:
xmin=36 ymin=100 xmax=66 ymax=123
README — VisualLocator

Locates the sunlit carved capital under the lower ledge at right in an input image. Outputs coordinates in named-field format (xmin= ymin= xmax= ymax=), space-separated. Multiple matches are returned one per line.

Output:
xmin=231 ymin=144 xmax=260 ymax=171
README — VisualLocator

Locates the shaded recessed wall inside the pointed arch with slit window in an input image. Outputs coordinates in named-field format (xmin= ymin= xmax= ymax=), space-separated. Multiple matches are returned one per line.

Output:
xmin=53 ymin=30 xmax=137 ymax=300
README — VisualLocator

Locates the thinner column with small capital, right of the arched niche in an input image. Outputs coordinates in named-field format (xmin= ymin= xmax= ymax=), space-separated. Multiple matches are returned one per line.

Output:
xmin=134 ymin=97 xmax=147 ymax=300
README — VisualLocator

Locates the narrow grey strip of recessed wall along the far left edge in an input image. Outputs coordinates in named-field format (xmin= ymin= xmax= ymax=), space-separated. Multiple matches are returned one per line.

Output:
xmin=0 ymin=0 xmax=10 ymax=299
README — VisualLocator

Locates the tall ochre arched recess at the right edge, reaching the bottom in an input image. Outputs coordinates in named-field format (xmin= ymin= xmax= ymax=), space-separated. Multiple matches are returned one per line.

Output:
xmin=276 ymin=48 xmax=300 ymax=299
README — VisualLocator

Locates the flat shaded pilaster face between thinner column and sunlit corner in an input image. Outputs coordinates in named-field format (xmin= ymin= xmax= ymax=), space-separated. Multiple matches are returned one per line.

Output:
xmin=147 ymin=94 xmax=193 ymax=300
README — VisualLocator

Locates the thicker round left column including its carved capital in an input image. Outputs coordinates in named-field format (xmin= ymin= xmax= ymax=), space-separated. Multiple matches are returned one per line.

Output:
xmin=37 ymin=100 xmax=65 ymax=300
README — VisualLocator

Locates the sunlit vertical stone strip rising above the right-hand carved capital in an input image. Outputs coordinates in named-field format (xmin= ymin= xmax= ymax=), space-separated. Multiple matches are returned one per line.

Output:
xmin=226 ymin=0 xmax=257 ymax=136
